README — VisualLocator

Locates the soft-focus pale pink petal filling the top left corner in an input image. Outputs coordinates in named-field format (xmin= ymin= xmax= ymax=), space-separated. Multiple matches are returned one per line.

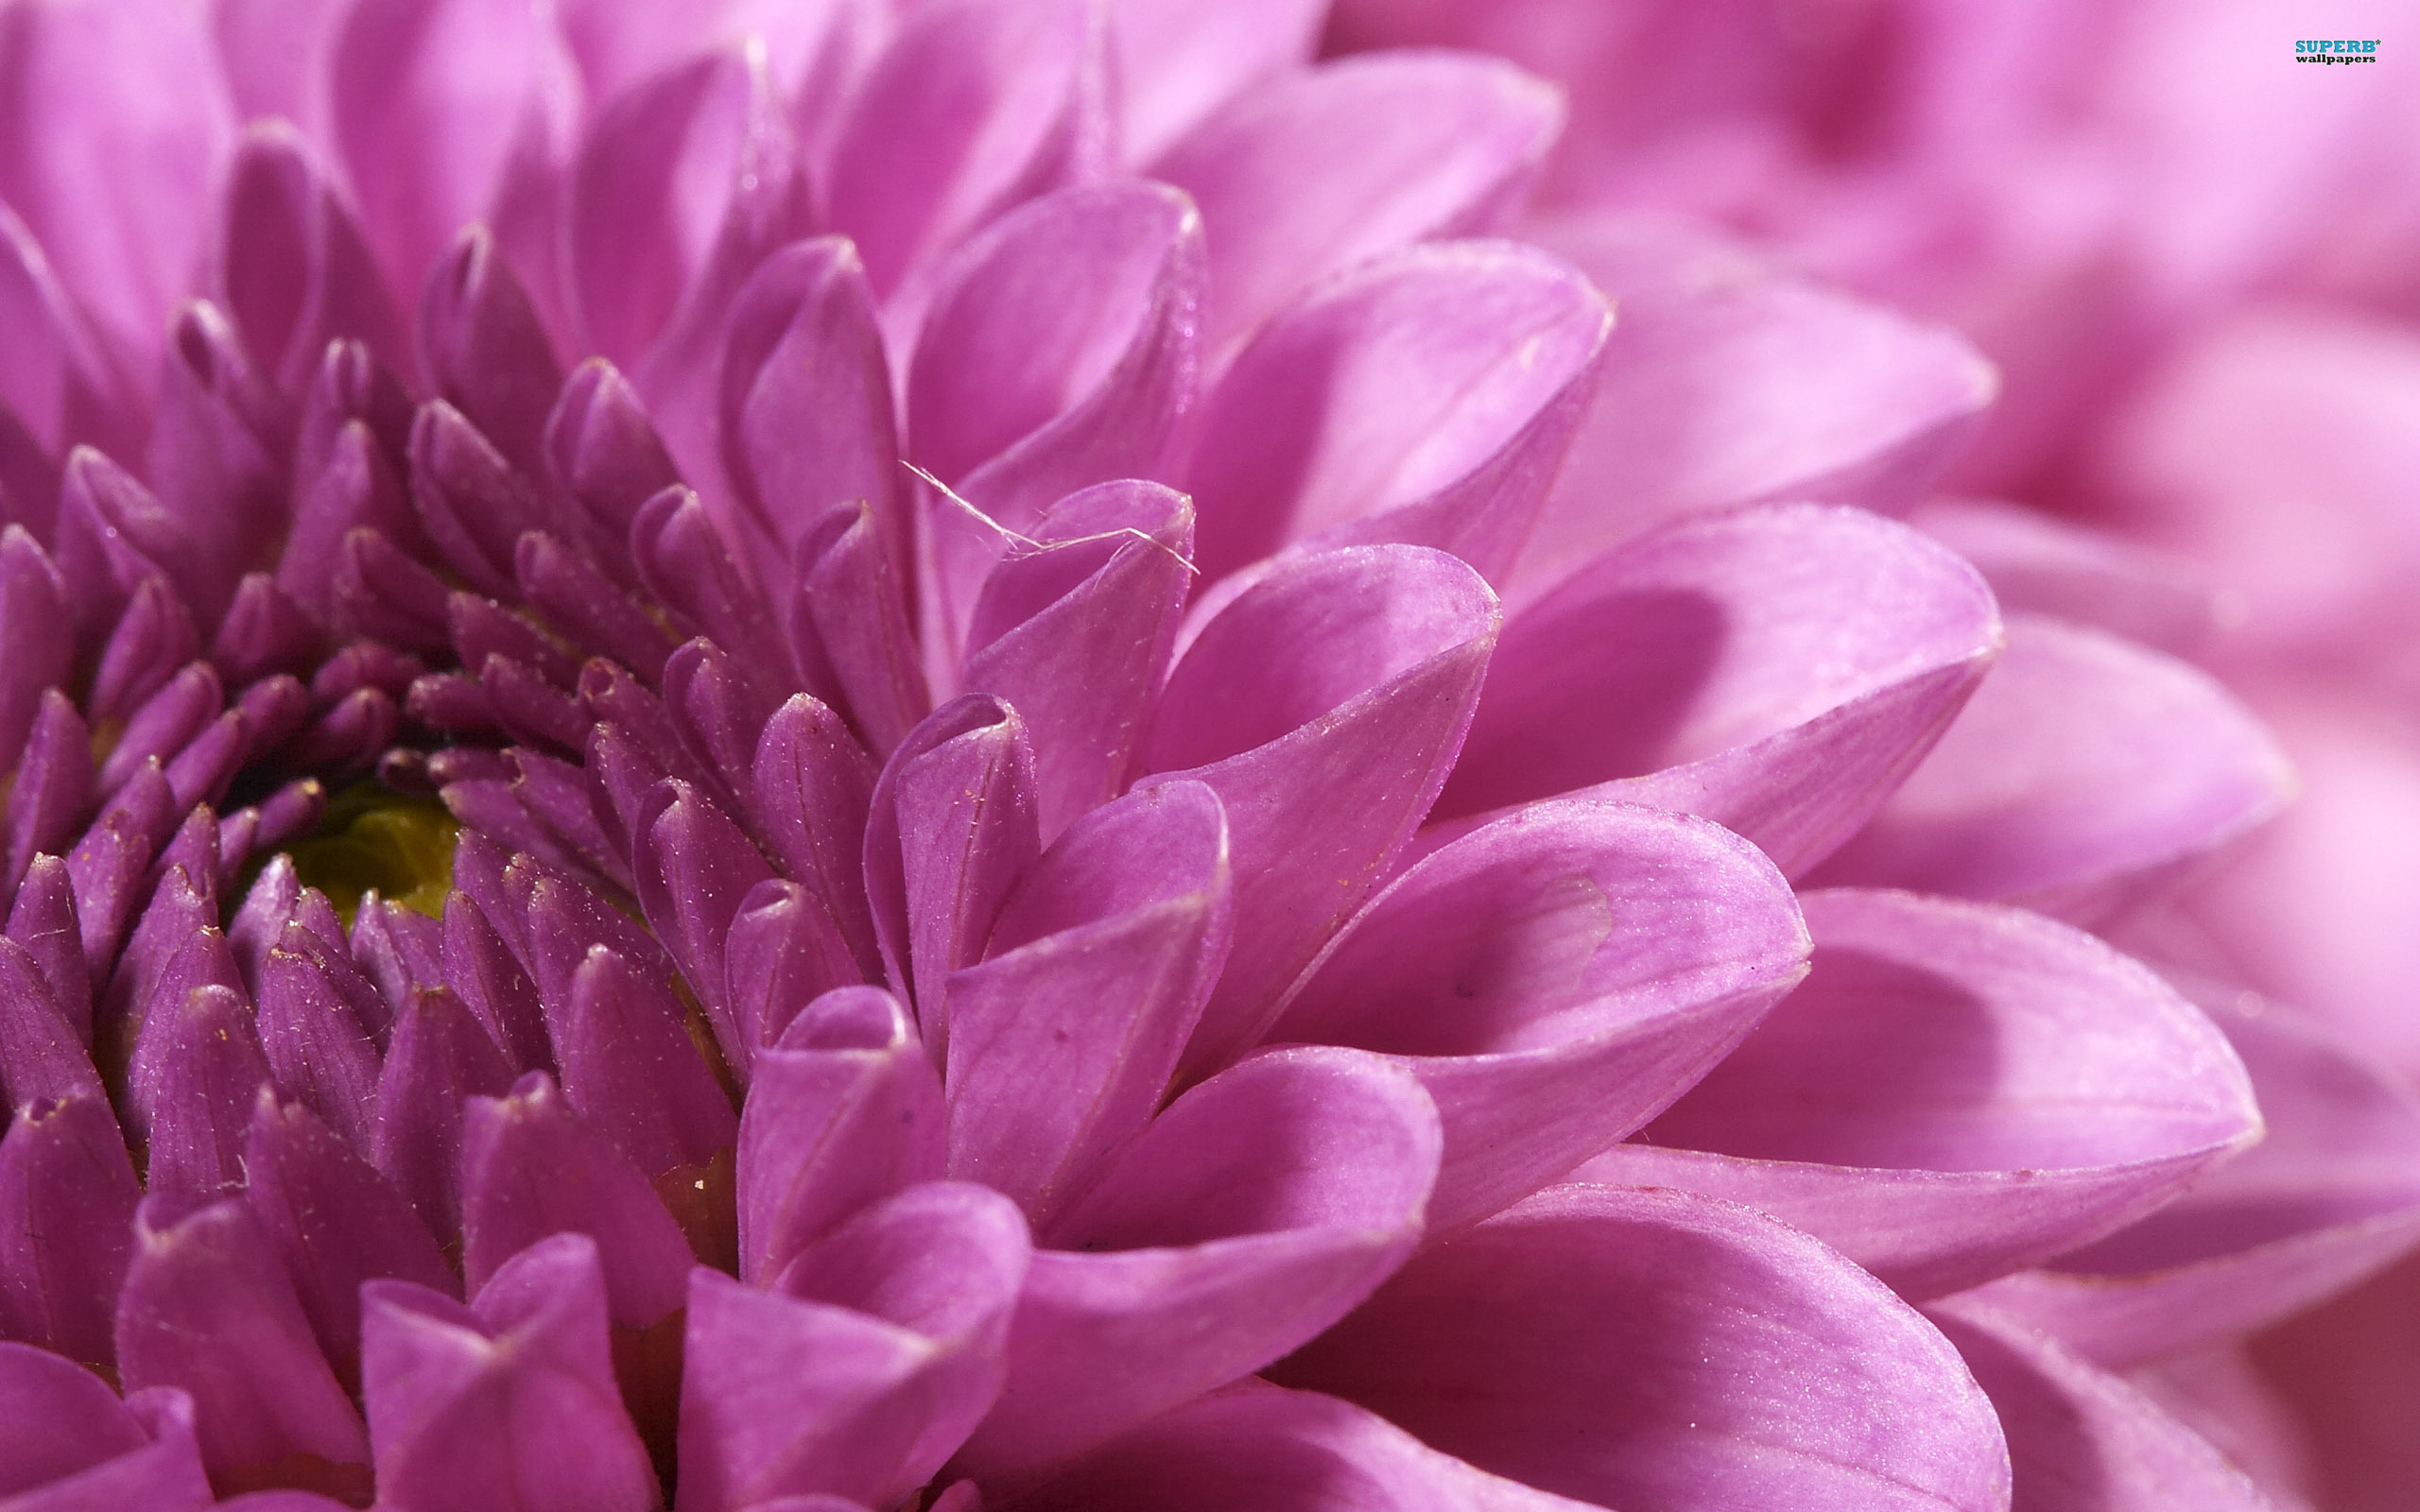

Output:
xmin=0 ymin=0 xmax=233 ymax=368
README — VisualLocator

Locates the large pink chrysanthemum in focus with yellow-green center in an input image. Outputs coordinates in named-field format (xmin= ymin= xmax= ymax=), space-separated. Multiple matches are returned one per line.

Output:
xmin=0 ymin=0 xmax=2384 ymax=1512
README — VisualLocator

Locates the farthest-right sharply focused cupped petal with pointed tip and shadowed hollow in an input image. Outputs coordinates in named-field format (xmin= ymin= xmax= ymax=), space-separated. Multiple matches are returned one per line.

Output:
xmin=1585 ymin=890 xmax=2260 ymax=1297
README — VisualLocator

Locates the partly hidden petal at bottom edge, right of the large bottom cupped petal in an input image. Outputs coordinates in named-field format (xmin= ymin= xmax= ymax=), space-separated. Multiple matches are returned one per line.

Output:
xmin=1927 ymin=1301 xmax=2274 ymax=1512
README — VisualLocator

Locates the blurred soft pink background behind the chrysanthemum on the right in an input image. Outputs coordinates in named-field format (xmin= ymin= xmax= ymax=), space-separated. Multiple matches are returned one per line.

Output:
xmin=1328 ymin=0 xmax=2420 ymax=1512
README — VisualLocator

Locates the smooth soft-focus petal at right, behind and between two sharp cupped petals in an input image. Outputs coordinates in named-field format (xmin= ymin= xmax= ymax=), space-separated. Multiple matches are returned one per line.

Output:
xmin=1815 ymin=614 xmax=2294 ymax=921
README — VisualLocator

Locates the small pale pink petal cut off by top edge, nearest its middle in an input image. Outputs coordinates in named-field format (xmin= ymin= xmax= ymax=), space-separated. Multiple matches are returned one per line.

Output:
xmin=1108 ymin=0 xmax=1326 ymax=167
